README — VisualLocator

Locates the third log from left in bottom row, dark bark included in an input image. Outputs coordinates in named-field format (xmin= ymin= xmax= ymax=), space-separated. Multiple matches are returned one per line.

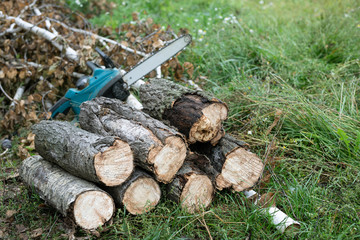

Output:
xmin=167 ymin=160 xmax=214 ymax=213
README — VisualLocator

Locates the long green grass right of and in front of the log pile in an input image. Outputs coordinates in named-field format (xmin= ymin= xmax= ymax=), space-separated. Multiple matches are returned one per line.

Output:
xmin=0 ymin=0 xmax=360 ymax=239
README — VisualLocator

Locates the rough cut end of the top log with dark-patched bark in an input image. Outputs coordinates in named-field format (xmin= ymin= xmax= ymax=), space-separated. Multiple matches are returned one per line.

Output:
xmin=188 ymin=102 xmax=228 ymax=145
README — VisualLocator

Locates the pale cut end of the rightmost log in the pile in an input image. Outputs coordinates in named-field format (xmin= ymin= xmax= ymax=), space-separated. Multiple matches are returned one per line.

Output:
xmin=216 ymin=148 xmax=264 ymax=192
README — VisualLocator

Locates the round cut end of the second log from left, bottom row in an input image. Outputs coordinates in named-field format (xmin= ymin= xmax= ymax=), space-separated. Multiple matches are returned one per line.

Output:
xmin=123 ymin=177 xmax=161 ymax=215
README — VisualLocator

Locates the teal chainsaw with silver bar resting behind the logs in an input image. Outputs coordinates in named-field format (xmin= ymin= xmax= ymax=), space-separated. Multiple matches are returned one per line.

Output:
xmin=50 ymin=34 xmax=191 ymax=118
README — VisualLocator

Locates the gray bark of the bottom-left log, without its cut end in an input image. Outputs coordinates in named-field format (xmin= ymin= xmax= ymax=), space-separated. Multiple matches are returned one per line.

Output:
xmin=19 ymin=155 xmax=115 ymax=228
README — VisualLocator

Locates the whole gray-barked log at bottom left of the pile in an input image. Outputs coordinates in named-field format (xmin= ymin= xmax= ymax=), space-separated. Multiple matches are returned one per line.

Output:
xmin=20 ymin=155 xmax=115 ymax=229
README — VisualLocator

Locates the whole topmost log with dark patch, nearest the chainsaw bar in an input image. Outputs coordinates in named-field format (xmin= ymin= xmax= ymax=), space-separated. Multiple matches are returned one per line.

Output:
xmin=139 ymin=79 xmax=228 ymax=145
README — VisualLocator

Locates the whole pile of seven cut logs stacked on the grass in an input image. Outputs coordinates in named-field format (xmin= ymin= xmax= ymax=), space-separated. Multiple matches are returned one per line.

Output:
xmin=20 ymin=79 xmax=263 ymax=229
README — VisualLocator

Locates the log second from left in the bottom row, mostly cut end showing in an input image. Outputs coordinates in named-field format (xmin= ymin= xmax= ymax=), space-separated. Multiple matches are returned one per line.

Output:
xmin=105 ymin=169 xmax=161 ymax=215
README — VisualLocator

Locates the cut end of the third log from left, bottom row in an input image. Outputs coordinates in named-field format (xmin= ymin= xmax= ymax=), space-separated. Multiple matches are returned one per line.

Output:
xmin=180 ymin=174 xmax=214 ymax=213
